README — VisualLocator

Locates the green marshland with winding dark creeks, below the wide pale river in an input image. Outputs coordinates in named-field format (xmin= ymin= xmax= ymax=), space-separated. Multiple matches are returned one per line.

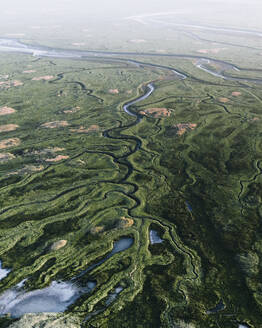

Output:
xmin=0 ymin=19 xmax=262 ymax=328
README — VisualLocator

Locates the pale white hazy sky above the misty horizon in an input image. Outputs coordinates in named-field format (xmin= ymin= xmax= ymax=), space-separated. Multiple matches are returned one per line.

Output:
xmin=0 ymin=0 xmax=262 ymax=18
